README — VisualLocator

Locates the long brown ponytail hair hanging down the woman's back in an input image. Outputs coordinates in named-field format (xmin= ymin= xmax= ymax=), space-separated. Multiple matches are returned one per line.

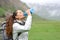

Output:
xmin=6 ymin=11 xmax=17 ymax=37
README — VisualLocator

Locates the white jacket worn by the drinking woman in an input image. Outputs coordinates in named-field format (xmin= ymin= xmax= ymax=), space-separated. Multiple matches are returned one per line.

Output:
xmin=13 ymin=16 xmax=32 ymax=40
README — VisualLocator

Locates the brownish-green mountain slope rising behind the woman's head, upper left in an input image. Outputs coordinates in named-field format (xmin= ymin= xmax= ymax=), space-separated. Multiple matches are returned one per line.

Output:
xmin=0 ymin=0 xmax=29 ymax=16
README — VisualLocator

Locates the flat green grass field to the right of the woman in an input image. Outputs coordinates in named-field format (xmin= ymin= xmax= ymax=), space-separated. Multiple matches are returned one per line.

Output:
xmin=29 ymin=14 xmax=60 ymax=40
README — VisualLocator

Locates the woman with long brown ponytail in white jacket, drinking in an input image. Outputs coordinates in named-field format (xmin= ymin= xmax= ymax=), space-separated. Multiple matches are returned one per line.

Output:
xmin=6 ymin=9 xmax=32 ymax=40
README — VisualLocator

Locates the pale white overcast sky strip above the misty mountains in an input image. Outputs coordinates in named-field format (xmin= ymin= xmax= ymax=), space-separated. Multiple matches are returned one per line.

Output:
xmin=21 ymin=0 xmax=60 ymax=4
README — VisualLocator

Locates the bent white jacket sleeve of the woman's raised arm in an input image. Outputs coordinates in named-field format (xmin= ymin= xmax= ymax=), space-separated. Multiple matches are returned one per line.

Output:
xmin=13 ymin=16 xmax=32 ymax=32
